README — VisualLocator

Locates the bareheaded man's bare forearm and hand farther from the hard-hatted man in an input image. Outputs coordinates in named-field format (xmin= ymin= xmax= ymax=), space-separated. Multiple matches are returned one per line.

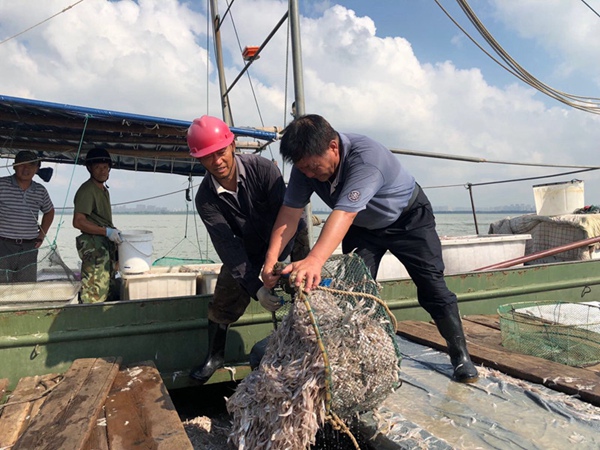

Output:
xmin=282 ymin=209 xmax=358 ymax=292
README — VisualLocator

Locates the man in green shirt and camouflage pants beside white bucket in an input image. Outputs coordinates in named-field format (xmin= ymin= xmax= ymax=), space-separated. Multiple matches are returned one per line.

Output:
xmin=73 ymin=148 xmax=123 ymax=303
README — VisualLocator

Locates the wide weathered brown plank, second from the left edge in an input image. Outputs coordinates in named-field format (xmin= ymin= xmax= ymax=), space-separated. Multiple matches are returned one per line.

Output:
xmin=13 ymin=357 xmax=121 ymax=450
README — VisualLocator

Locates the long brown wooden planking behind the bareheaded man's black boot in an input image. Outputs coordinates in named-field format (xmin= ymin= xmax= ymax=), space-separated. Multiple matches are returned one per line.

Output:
xmin=398 ymin=321 xmax=600 ymax=406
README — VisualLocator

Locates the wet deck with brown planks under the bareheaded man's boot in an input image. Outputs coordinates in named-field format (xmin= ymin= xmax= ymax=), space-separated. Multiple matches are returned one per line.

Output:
xmin=361 ymin=316 xmax=600 ymax=450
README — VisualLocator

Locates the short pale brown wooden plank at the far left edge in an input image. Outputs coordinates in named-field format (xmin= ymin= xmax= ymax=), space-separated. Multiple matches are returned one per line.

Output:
xmin=0 ymin=374 xmax=62 ymax=448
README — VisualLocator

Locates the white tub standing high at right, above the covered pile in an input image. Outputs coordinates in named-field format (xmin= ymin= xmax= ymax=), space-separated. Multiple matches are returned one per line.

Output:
xmin=533 ymin=180 xmax=585 ymax=216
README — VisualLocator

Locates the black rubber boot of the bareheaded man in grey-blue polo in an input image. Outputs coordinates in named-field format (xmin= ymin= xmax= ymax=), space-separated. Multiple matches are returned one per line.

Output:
xmin=434 ymin=304 xmax=479 ymax=383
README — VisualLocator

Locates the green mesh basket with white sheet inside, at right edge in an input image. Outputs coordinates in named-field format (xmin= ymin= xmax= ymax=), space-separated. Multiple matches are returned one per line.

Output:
xmin=498 ymin=302 xmax=600 ymax=367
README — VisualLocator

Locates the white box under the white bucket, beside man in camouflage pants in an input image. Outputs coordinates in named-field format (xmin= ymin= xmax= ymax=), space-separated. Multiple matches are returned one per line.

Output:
xmin=121 ymin=269 xmax=196 ymax=300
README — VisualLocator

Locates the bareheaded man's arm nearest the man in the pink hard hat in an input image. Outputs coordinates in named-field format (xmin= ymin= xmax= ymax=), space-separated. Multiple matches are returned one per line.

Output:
xmin=262 ymin=206 xmax=304 ymax=289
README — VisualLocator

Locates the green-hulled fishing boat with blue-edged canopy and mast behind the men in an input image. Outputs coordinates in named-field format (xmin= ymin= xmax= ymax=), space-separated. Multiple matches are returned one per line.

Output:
xmin=0 ymin=1 xmax=600 ymax=400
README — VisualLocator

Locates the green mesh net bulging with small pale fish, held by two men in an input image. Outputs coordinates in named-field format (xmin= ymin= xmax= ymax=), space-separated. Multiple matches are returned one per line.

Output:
xmin=227 ymin=255 xmax=401 ymax=450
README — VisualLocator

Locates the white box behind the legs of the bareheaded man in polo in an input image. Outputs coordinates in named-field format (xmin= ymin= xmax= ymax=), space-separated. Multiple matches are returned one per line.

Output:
xmin=377 ymin=234 xmax=531 ymax=280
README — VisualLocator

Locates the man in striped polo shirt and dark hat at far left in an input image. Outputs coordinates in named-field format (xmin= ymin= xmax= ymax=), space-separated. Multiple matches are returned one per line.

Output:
xmin=0 ymin=151 xmax=54 ymax=283
